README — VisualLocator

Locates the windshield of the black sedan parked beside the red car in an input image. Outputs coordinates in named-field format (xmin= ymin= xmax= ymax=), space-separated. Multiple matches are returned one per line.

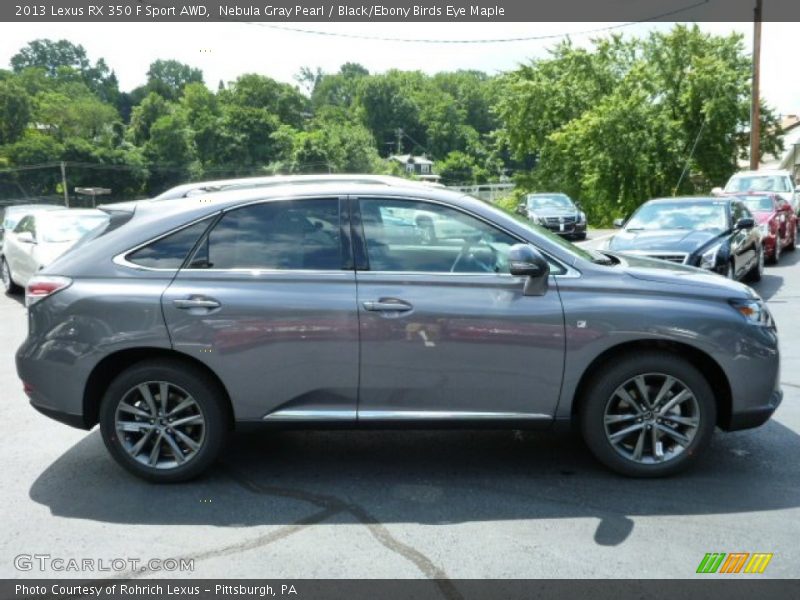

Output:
xmin=625 ymin=200 xmax=728 ymax=232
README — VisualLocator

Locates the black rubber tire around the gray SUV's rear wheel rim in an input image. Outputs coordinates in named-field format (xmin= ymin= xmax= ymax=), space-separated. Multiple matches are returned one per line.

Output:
xmin=99 ymin=359 xmax=230 ymax=483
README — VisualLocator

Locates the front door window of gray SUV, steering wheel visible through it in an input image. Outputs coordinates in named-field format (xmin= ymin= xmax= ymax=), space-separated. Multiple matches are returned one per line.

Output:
xmin=359 ymin=198 xmax=518 ymax=273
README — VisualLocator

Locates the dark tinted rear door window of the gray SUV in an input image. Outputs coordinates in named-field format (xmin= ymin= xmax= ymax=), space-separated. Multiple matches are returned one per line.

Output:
xmin=190 ymin=198 xmax=342 ymax=271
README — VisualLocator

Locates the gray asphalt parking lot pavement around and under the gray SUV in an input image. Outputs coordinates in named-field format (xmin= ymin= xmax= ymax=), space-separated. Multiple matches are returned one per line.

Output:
xmin=0 ymin=241 xmax=800 ymax=580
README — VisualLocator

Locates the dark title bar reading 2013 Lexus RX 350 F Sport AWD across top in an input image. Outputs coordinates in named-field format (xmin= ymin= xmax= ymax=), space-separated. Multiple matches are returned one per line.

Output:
xmin=0 ymin=0 xmax=800 ymax=23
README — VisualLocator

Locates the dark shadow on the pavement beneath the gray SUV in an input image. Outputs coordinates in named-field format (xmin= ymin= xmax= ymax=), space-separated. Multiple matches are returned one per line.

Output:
xmin=29 ymin=420 xmax=800 ymax=546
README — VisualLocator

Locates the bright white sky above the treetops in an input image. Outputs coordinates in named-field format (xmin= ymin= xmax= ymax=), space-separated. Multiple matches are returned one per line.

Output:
xmin=0 ymin=22 xmax=800 ymax=114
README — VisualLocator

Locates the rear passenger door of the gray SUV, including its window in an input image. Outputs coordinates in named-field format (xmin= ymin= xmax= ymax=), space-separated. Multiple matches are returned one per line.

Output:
xmin=162 ymin=197 xmax=358 ymax=421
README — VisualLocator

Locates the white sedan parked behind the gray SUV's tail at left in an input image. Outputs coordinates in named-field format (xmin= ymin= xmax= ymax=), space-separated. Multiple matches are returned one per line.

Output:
xmin=0 ymin=208 xmax=108 ymax=293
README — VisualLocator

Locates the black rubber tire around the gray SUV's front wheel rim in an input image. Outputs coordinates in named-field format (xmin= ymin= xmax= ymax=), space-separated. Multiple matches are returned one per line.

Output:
xmin=579 ymin=352 xmax=717 ymax=477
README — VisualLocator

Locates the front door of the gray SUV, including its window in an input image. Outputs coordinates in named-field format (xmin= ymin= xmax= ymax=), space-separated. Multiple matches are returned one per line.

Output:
xmin=353 ymin=198 xmax=565 ymax=421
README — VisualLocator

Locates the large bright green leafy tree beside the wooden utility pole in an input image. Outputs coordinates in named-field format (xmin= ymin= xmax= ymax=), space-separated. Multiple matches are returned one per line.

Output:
xmin=497 ymin=25 xmax=780 ymax=222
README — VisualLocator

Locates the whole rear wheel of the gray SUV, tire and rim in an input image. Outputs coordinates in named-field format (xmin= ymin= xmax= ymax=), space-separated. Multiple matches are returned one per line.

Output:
xmin=100 ymin=360 xmax=229 ymax=483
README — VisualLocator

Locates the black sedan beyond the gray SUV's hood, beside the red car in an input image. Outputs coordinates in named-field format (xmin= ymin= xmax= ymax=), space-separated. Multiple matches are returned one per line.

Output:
xmin=608 ymin=198 xmax=764 ymax=281
